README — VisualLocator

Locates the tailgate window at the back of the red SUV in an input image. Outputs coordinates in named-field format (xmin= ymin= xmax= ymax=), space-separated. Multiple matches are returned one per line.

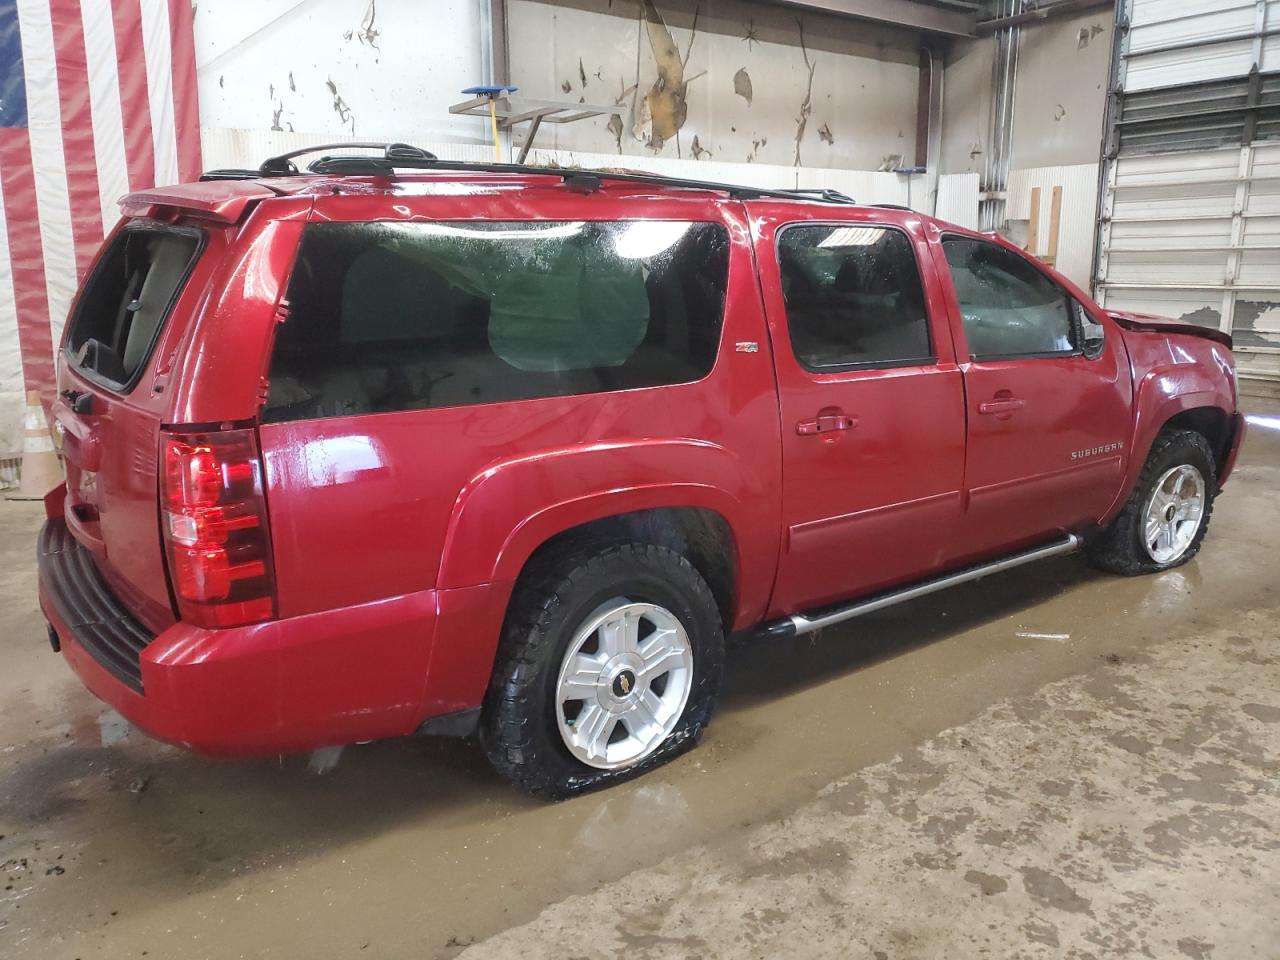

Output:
xmin=67 ymin=227 xmax=202 ymax=389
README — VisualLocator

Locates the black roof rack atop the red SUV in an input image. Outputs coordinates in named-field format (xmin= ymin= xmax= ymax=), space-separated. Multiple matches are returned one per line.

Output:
xmin=201 ymin=141 xmax=858 ymax=204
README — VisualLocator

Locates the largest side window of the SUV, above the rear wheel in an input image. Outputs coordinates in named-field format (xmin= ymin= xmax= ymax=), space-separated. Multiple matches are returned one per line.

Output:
xmin=264 ymin=220 xmax=728 ymax=422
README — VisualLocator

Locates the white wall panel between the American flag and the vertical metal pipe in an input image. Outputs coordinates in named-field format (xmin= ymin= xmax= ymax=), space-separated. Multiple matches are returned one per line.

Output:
xmin=195 ymin=0 xmax=486 ymax=146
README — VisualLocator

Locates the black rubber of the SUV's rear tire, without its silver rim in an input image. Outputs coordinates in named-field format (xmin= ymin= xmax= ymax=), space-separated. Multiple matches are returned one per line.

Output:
xmin=480 ymin=543 xmax=724 ymax=800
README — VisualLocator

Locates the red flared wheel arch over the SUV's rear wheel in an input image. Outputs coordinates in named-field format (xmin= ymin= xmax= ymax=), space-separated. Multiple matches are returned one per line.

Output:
xmin=438 ymin=440 xmax=780 ymax=630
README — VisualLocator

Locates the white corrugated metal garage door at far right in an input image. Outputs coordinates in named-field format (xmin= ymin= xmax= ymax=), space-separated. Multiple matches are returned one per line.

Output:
xmin=1096 ymin=0 xmax=1280 ymax=381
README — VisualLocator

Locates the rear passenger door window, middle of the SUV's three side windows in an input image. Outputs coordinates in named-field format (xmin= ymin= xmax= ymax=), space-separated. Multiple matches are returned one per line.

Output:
xmin=778 ymin=224 xmax=933 ymax=372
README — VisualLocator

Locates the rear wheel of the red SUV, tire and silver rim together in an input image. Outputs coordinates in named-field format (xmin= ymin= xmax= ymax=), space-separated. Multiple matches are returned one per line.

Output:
xmin=480 ymin=543 xmax=724 ymax=799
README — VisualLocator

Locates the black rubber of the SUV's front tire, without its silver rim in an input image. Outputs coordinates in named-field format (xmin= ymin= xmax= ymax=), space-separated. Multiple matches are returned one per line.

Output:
xmin=1085 ymin=429 xmax=1217 ymax=576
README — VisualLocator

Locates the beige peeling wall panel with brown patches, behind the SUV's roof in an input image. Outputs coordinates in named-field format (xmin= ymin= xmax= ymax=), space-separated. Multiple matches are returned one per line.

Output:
xmin=508 ymin=0 xmax=920 ymax=170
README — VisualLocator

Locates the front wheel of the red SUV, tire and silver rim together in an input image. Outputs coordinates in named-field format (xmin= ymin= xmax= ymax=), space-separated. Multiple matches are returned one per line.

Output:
xmin=1085 ymin=429 xmax=1217 ymax=576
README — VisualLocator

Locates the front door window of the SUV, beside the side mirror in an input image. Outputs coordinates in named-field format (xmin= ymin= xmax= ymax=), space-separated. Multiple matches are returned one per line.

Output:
xmin=942 ymin=237 xmax=1075 ymax=357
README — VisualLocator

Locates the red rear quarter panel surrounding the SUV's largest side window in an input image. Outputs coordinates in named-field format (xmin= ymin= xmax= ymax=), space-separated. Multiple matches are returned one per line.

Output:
xmin=260 ymin=189 xmax=781 ymax=634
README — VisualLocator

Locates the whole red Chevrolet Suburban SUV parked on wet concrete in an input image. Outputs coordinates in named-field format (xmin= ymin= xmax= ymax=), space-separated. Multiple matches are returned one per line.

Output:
xmin=38 ymin=145 xmax=1244 ymax=797
